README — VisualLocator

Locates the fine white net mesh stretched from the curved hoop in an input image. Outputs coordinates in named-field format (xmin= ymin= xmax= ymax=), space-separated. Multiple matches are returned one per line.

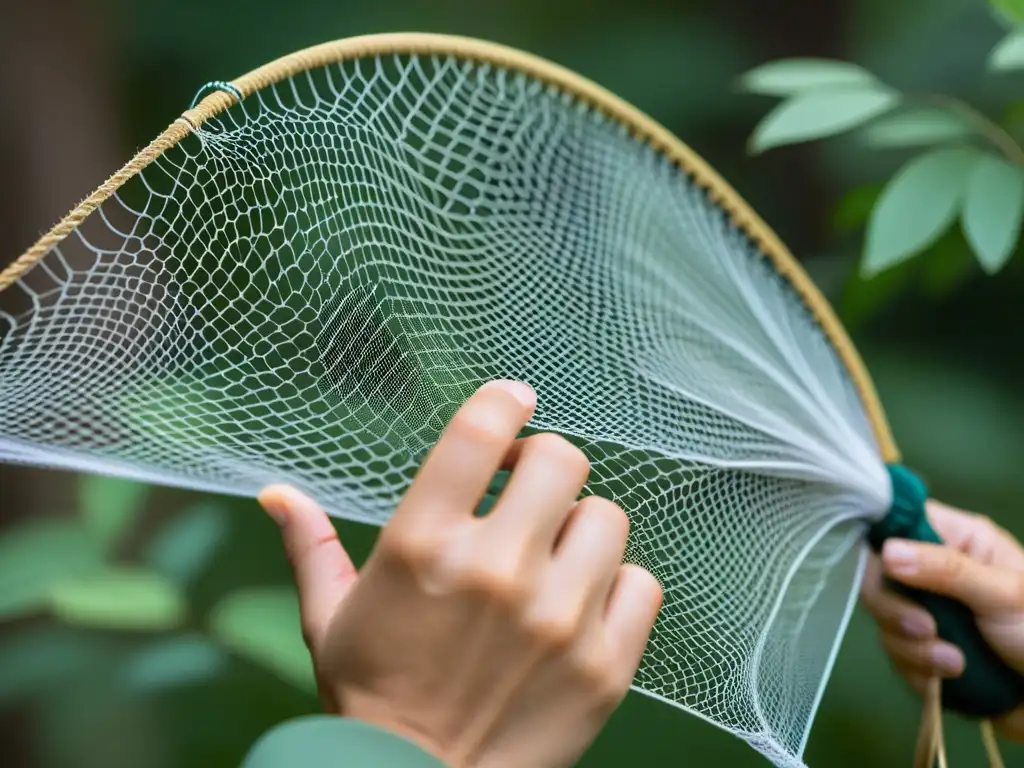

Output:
xmin=0 ymin=54 xmax=890 ymax=766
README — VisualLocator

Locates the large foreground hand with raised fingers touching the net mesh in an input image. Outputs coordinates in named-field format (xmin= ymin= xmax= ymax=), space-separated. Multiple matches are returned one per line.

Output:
xmin=260 ymin=382 xmax=662 ymax=768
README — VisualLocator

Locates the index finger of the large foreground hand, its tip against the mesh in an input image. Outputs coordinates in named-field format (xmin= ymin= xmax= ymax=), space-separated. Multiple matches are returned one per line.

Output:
xmin=392 ymin=381 xmax=537 ymax=524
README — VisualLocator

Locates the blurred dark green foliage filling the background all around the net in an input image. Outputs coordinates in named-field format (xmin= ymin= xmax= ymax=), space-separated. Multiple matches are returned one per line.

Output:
xmin=0 ymin=0 xmax=1024 ymax=768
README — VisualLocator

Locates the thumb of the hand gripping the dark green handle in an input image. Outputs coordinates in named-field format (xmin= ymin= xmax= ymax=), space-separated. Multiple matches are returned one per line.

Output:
xmin=882 ymin=540 xmax=1024 ymax=616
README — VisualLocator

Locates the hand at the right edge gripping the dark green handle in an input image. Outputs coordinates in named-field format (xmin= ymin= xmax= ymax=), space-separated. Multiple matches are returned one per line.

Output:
xmin=861 ymin=502 xmax=1024 ymax=740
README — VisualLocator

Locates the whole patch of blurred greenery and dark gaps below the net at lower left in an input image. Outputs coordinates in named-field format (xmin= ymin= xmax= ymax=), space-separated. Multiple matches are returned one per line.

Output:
xmin=0 ymin=475 xmax=315 ymax=768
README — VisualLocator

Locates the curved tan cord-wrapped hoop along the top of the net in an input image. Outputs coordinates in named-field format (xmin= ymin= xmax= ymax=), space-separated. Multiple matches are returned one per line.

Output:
xmin=0 ymin=32 xmax=900 ymax=463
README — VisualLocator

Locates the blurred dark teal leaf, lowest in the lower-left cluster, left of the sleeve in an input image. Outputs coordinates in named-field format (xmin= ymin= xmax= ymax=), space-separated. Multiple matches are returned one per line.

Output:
xmin=121 ymin=635 xmax=227 ymax=691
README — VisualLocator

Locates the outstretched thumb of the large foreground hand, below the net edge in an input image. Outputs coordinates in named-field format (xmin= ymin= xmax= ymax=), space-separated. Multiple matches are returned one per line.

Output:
xmin=259 ymin=485 xmax=358 ymax=649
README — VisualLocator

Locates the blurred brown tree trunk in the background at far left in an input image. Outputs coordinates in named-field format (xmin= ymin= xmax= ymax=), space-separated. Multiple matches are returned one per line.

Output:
xmin=0 ymin=0 xmax=125 ymax=524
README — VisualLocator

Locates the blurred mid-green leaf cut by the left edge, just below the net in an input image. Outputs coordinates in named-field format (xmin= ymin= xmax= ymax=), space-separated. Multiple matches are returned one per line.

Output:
xmin=0 ymin=520 xmax=103 ymax=616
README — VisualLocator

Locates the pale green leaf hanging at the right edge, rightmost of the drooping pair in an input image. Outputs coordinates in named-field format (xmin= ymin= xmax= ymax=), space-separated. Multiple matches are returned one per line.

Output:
xmin=964 ymin=155 xmax=1024 ymax=274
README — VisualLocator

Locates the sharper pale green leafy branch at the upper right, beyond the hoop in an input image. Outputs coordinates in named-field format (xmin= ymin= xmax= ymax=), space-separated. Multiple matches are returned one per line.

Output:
xmin=739 ymin=0 xmax=1024 ymax=278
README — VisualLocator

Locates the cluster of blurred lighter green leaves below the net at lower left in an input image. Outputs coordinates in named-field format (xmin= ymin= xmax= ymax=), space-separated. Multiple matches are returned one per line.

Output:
xmin=0 ymin=475 xmax=312 ymax=690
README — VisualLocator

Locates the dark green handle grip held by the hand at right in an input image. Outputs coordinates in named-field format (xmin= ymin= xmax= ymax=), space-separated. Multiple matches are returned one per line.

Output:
xmin=868 ymin=466 xmax=1024 ymax=719
